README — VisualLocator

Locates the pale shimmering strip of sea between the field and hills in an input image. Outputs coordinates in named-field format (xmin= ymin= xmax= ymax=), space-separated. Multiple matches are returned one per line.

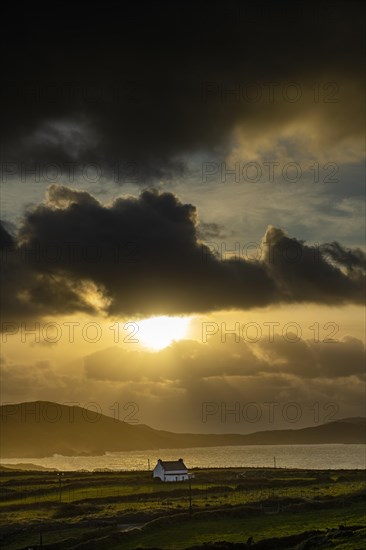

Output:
xmin=1 ymin=444 xmax=366 ymax=471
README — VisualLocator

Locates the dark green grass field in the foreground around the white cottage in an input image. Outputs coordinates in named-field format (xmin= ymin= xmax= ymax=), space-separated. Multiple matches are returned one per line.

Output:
xmin=0 ymin=468 xmax=366 ymax=550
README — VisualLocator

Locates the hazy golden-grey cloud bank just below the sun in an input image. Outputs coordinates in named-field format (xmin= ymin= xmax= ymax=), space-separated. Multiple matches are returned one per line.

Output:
xmin=84 ymin=334 xmax=365 ymax=389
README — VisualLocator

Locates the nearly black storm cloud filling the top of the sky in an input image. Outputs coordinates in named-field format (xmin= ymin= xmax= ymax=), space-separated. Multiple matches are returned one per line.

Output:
xmin=2 ymin=2 xmax=363 ymax=182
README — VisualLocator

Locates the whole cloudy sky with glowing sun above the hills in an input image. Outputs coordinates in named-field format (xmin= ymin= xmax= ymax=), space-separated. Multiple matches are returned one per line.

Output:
xmin=0 ymin=0 xmax=366 ymax=433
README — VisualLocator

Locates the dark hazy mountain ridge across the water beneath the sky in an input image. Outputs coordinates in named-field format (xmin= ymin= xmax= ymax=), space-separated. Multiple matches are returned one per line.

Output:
xmin=0 ymin=401 xmax=366 ymax=458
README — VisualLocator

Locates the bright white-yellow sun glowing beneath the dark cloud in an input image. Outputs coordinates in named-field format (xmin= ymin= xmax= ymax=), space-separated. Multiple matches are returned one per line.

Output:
xmin=136 ymin=315 xmax=191 ymax=350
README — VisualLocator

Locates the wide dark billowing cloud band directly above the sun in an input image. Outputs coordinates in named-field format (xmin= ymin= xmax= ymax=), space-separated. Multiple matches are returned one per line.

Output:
xmin=2 ymin=186 xmax=364 ymax=320
